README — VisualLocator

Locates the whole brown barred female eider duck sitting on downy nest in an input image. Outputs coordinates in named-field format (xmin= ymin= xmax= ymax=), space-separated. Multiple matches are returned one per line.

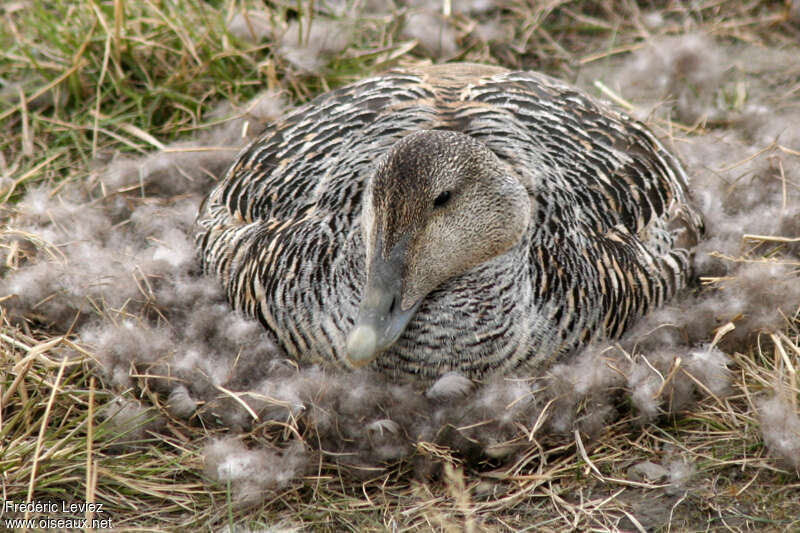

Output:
xmin=198 ymin=64 xmax=702 ymax=382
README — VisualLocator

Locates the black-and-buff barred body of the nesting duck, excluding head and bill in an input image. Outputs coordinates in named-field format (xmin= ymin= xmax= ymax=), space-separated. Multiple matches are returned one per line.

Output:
xmin=198 ymin=64 xmax=701 ymax=376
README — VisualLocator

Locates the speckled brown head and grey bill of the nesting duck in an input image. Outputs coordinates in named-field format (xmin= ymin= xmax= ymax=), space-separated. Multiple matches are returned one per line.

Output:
xmin=347 ymin=130 xmax=531 ymax=366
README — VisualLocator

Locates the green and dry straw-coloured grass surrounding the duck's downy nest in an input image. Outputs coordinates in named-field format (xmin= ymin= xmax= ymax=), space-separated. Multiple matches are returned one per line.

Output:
xmin=0 ymin=0 xmax=800 ymax=532
